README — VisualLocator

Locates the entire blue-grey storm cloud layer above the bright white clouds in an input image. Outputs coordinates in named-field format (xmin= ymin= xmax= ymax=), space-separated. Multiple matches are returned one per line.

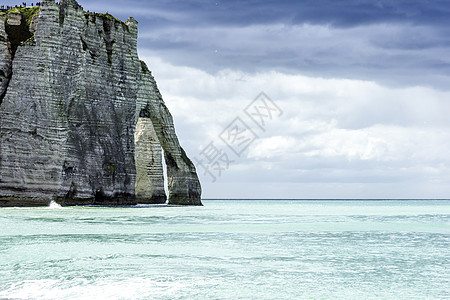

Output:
xmin=4 ymin=0 xmax=442 ymax=89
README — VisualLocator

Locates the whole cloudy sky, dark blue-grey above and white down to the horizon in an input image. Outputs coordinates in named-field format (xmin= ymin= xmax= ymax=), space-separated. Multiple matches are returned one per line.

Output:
xmin=15 ymin=0 xmax=450 ymax=198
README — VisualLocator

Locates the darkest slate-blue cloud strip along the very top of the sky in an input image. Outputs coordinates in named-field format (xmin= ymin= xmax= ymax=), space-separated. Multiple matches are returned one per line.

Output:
xmin=81 ymin=0 xmax=450 ymax=27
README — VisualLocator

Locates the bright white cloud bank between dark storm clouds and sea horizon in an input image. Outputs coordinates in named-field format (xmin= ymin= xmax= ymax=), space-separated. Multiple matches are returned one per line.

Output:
xmin=141 ymin=52 xmax=450 ymax=198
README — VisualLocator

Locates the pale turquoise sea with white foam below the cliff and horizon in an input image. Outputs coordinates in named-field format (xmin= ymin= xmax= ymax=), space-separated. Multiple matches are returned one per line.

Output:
xmin=0 ymin=200 xmax=450 ymax=299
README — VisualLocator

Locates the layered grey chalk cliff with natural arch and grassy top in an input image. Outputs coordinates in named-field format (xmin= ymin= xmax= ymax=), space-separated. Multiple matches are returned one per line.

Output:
xmin=0 ymin=0 xmax=201 ymax=206
